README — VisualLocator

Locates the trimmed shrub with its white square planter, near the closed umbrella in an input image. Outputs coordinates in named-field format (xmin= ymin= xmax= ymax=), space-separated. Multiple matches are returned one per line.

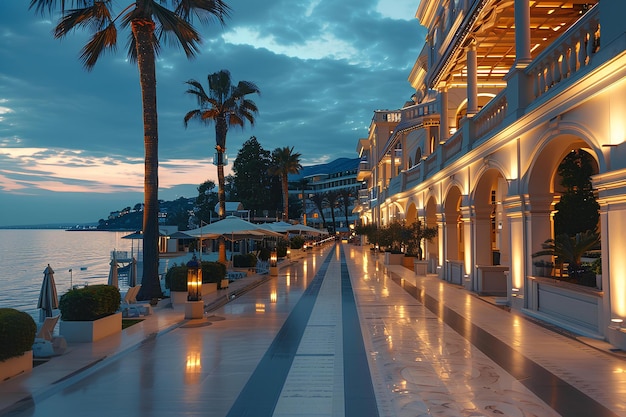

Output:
xmin=59 ymin=285 xmax=122 ymax=342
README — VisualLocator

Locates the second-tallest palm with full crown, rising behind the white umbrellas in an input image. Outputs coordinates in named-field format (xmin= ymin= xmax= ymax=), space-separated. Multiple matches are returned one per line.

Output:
xmin=183 ymin=69 xmax=261 ymax=263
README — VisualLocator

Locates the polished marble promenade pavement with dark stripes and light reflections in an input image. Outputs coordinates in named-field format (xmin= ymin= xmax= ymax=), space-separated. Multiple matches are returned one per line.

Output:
xmin=0 ymin=244 xmax=626 ymax=417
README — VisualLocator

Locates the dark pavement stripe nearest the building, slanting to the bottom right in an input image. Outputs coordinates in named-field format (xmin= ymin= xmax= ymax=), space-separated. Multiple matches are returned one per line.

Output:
xmin=392 ymin=274 xmax=618 ymax=417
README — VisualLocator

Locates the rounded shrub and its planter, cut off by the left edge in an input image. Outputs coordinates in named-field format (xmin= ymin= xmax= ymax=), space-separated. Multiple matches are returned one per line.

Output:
xmin=0 ymin=308 xmax=37 ymax=381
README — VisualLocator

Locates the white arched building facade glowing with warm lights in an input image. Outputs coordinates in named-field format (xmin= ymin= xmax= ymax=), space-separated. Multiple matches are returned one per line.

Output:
xmin=357 ymin=0 xmax=626 ymax=349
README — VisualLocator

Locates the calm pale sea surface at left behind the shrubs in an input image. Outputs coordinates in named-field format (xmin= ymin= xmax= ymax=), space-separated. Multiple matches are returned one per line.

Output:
xmin=0 ymin=230 xmax=138 ymax=321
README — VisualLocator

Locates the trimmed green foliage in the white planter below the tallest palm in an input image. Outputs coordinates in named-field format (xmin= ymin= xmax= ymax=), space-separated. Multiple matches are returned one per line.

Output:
xmin=59 ymin=285 xmax=121 ymax=321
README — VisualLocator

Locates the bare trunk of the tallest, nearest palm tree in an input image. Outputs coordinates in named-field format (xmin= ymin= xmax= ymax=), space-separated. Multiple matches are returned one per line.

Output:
xmin=131 ymin=19 xmax=163 ymax=300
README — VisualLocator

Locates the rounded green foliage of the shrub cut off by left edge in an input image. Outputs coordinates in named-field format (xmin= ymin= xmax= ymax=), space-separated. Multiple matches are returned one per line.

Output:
xmin=0 ymin=308 xmax=37 ymax=362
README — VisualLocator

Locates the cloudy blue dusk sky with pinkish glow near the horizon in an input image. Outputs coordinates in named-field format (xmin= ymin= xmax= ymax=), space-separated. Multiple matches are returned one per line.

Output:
xmin=0 ymin=0 xmax=425 ymax=227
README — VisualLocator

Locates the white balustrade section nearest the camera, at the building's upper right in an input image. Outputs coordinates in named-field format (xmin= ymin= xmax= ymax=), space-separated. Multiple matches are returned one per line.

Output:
xmin=526 ymin=6 xmax=600 ymax=99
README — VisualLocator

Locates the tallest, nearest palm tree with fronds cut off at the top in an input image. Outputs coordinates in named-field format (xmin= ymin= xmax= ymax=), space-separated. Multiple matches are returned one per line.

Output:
xmin=29 ymin=0 xmax=230 ymax=300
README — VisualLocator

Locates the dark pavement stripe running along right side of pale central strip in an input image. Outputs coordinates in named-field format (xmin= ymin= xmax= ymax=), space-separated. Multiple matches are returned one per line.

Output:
xmin=341 ymin=249 xmax=378 ymax=417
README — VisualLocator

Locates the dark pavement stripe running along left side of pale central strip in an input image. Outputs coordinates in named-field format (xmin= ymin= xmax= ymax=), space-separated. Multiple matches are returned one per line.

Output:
xmin=227 ymin=250 xmax=334 ymax=417
